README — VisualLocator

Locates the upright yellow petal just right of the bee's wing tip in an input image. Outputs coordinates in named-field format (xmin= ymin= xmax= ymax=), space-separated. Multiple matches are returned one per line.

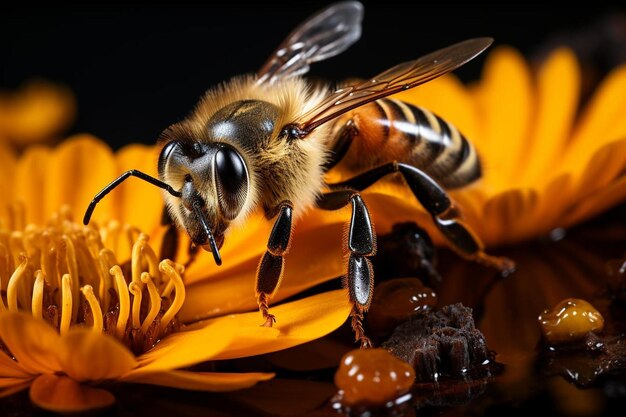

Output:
xmin=469 ymin=47 xmax=535 ymax=192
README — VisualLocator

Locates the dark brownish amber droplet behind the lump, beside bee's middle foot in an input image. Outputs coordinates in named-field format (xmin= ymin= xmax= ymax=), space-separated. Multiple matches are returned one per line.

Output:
xmin=367 ymin=278 xmax=437 ymax=337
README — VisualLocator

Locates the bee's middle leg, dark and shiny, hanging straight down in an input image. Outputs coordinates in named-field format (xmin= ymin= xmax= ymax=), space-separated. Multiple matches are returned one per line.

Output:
xmin=317 ymin=190 xmax=376 ymax=348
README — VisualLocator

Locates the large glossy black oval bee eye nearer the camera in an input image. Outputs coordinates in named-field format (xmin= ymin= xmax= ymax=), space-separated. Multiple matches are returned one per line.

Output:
xmin=214 ymin=146 xmax=249 ymax=220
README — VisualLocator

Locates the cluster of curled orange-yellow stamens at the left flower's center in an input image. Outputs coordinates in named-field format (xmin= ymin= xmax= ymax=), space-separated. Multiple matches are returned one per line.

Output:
xmin=0 ymin=205 xmax=185 ymax=354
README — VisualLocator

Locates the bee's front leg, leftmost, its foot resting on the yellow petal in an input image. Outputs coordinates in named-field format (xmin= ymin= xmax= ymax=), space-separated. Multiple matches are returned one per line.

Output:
xmin=256 ymin=201 xmax=293 ymax=327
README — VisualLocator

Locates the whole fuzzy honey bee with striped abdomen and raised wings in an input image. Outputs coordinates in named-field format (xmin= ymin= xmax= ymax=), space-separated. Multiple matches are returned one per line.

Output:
xmin=84 ymin=1 xmax=513 ymax=347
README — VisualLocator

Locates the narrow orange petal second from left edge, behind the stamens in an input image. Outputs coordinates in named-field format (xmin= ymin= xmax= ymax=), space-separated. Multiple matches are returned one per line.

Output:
xmin=14 ymin=146 xmax=51 ymax=225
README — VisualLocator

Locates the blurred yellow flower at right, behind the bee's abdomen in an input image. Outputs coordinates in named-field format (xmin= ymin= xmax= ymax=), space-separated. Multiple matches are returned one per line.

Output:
xmin=346 ymin=47 xmax=626 ymax=246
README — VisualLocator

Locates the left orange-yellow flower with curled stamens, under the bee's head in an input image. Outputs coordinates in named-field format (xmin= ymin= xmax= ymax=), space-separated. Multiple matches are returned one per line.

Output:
xmin=0 ymin=136 xmax=350 ymax=412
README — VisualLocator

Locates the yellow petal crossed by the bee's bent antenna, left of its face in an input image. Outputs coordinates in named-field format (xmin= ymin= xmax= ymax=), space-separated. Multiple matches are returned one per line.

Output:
xmin=114 ymin=145 xmax=163 ymax=236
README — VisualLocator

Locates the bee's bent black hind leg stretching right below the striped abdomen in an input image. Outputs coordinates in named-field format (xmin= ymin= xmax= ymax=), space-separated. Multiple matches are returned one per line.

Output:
xmin=328 ymin=161 xmax=515 ymax=274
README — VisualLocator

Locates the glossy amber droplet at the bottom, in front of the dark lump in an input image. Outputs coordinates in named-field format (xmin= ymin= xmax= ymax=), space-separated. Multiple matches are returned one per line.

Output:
xmin=335 ymin=348 xmax=415 ymax=405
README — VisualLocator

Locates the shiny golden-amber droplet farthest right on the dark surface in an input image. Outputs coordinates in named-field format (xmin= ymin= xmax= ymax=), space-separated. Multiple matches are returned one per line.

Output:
xmin=539 ymin=298 xmax=604 ymax=344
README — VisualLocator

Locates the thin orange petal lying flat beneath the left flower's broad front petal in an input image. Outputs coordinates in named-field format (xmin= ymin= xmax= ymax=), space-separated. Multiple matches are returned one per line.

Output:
xmin=124 ymin=371 xmax=274 ymax=392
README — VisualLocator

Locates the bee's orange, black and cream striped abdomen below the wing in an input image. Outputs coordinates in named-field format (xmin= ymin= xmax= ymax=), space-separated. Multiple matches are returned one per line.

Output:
xmin=336 ymin=98 xmax=481 ymax=188
